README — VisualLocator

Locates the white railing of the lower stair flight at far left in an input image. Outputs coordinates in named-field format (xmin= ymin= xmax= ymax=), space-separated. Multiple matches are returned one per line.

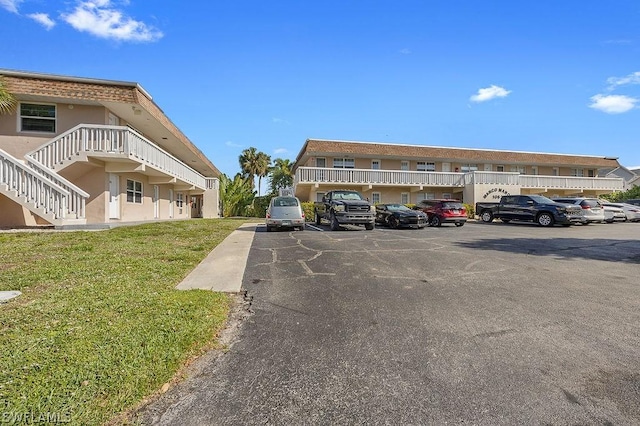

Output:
xmin=0 ymin=149 xmax=83 ymax=225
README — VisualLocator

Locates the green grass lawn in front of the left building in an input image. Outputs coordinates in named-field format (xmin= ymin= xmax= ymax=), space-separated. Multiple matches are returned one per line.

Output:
xmin=0 ymin=219 xmax=246 ymax=425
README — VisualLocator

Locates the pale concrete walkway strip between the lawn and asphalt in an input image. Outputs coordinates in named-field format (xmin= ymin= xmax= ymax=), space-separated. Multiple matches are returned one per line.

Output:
xmin=176 ymin=223 xmax=258 ymax=293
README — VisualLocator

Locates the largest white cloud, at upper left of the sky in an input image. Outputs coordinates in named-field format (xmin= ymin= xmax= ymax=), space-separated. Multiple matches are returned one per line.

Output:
xmin=62 ymin=0 xmax=163 ymax=42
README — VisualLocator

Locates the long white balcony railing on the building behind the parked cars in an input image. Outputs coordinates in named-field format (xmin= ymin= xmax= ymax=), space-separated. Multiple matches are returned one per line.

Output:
xmin=295 ymin=167 xmax=624 ymax=191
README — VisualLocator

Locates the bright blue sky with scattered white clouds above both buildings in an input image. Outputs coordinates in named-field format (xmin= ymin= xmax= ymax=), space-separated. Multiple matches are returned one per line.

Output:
xmin=0 ymin=0 xmax=640 ymax=175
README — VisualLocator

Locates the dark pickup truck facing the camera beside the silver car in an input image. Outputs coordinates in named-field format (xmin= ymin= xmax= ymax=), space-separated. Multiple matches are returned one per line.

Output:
xmin=313 ymin=190 xmax=376 ymax=231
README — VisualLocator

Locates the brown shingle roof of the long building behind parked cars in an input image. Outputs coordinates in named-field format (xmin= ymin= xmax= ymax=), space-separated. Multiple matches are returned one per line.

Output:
xmin=295 ymin=139 xmax=620 ymax=168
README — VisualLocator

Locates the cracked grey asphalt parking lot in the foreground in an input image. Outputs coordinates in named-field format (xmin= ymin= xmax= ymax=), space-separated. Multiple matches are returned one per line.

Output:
xmin=147 ymin=222 xmax=640 ymax=425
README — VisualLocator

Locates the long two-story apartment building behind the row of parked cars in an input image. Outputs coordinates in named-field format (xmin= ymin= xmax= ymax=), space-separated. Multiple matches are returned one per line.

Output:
xmin=294 ymin=139 xmax=624 ymax=204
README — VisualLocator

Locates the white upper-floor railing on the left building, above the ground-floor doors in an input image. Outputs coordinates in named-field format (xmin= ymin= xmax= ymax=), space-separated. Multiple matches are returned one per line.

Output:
xmin=27 ymin=124 xmax=206 ymax=189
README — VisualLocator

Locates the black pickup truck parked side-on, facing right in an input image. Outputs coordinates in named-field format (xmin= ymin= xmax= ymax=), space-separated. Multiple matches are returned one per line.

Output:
xmin=476 ymin=195 xmax=582 ymax=226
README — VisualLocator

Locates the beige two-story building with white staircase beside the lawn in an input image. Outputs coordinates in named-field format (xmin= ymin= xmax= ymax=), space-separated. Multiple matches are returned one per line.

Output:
xmin=0 ymin=69 xmax=220 ymax=227
